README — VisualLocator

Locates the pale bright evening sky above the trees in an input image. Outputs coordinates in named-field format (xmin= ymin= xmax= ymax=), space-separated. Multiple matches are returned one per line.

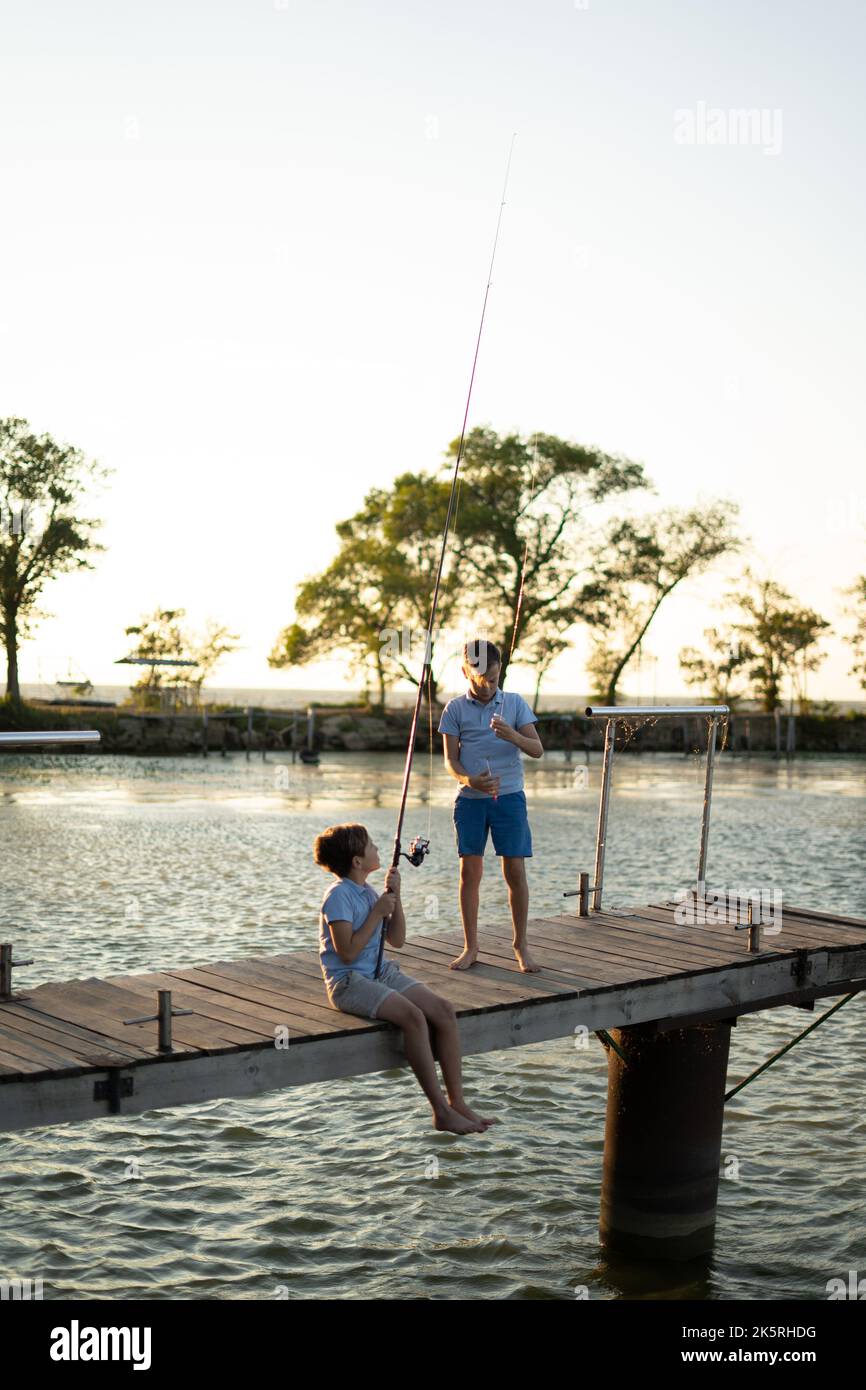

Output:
xmin=0 ymin=0 xmax=866 ymax=698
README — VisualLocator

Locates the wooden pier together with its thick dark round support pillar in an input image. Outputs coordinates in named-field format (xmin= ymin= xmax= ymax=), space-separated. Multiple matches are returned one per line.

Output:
xmin=0 ymin=902 xmax=866 ymax=1261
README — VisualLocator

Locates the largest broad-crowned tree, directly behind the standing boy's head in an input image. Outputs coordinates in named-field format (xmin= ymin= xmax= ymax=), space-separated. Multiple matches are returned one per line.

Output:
xmin=268 ymin=428 xmax=648 ymax=703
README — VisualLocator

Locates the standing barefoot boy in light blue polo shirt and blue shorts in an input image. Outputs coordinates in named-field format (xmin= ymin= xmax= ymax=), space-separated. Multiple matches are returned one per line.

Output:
xmin=439 ymin=638 xmax=544 ymax=972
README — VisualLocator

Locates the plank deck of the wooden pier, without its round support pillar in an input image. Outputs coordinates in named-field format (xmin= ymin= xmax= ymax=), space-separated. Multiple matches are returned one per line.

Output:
xmin=0 ymin=904 xmax=866 ymax=1130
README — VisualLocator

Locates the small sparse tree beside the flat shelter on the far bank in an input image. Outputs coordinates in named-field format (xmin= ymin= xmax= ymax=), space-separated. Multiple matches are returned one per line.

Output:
xmin=124 ymin=609 xmax=238 ymax=708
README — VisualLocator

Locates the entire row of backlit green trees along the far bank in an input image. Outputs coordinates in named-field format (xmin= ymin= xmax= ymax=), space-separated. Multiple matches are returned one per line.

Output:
xmin=0 ymin=408 xmax=866 ymax=710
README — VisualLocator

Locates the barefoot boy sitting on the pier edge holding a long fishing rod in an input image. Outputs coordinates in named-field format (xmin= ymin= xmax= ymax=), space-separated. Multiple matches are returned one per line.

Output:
xmin=313 ymin=824 xmax=496 ymax=1134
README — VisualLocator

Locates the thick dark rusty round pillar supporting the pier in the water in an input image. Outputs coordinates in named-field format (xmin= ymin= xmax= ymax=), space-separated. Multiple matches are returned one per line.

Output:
xmin=599 ymin=1019 xmax=731 ymax=1259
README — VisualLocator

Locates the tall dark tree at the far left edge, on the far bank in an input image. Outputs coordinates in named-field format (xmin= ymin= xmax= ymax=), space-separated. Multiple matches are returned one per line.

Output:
xmin=0 ymin=417 xmax=108 ymax=702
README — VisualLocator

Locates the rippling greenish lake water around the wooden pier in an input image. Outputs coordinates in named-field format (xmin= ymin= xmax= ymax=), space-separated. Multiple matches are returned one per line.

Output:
xmin=0 ymin=753 xmax=866 ymax=1300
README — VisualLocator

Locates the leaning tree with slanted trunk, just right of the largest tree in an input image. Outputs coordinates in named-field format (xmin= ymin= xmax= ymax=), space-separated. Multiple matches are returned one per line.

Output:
xmin=580 ymin=500 xmax=740 ymax=705
